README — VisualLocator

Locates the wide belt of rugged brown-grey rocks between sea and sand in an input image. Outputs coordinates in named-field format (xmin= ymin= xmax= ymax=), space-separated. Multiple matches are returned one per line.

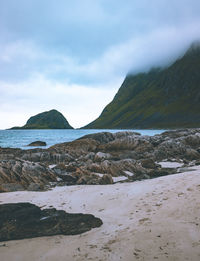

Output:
xmin=0 ymin=129 xmax=200 ymax=192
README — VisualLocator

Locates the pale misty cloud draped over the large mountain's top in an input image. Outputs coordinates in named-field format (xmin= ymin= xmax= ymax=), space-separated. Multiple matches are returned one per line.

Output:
xmin=97 ymin=20 xmax=200 ymax=75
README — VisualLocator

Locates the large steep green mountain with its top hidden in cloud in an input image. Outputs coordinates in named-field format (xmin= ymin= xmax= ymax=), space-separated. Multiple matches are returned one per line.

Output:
xmin=84 ymin=43 xmax=200 ymax=129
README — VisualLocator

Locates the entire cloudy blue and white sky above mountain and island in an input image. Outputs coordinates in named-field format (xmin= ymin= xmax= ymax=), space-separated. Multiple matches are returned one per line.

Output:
xmin=0 ymin=0 xmax=200 ymax=129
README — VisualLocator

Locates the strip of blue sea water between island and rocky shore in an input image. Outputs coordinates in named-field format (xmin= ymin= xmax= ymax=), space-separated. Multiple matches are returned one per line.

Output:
xmin=0 ymin=129 xmax=164 ymax=149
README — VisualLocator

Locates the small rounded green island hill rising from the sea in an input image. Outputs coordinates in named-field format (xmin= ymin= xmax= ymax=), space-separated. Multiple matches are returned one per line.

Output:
xmin=12 ymin=110 xmax=73 ymax=129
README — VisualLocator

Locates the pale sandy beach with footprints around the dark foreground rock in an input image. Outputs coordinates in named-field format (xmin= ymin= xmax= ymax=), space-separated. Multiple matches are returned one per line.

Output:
xmin=0 ymin=167 xmax=200 ymax=261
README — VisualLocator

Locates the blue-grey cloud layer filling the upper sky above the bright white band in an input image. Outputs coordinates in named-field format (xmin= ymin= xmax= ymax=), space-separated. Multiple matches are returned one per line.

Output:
xmin=0 ymin=0 xmax=200 ymax=86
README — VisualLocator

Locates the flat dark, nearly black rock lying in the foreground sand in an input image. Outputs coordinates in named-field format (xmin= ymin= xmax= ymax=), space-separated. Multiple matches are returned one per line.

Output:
xmin=0 ymin=203 xmax=102 ymax=241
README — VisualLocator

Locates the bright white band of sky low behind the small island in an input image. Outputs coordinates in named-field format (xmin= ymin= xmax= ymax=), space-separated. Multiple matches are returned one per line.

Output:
xmin=0 ymin=74 xmax=121 ymax=129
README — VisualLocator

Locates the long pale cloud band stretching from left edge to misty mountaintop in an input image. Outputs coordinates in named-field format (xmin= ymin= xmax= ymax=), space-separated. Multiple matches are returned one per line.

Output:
xmin=0 ymin=21 xmax=200 ymax=87
